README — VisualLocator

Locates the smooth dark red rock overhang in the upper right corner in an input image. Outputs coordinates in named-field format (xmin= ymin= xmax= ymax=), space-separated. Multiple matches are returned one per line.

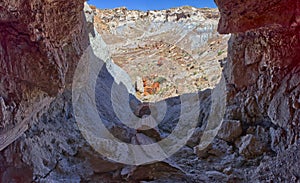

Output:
xmin=215 ymin=0 xmax=300 ymax=33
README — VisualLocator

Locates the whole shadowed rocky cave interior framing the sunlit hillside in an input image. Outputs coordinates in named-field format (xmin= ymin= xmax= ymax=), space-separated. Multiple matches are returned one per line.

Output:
xmin=0 ymin=0 xmax=300 ymax=183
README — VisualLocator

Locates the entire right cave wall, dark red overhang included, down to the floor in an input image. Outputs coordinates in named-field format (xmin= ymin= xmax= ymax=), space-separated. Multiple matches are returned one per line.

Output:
xmin=216 ymin=0 xmax=300 ymax=182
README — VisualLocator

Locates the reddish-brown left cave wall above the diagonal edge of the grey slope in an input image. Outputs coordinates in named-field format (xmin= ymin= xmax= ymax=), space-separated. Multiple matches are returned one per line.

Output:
xmin=0 ymin=0 xmax=88 ymax=150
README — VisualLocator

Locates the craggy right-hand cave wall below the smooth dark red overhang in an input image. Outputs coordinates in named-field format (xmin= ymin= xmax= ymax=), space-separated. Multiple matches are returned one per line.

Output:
xmin=224 ymin=26 xmax=300 ymax=151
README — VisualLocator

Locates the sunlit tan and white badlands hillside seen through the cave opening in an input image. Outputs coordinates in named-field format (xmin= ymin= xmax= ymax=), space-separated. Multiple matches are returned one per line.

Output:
xmin=92 ymin=6 xmax=229 ymax=101
